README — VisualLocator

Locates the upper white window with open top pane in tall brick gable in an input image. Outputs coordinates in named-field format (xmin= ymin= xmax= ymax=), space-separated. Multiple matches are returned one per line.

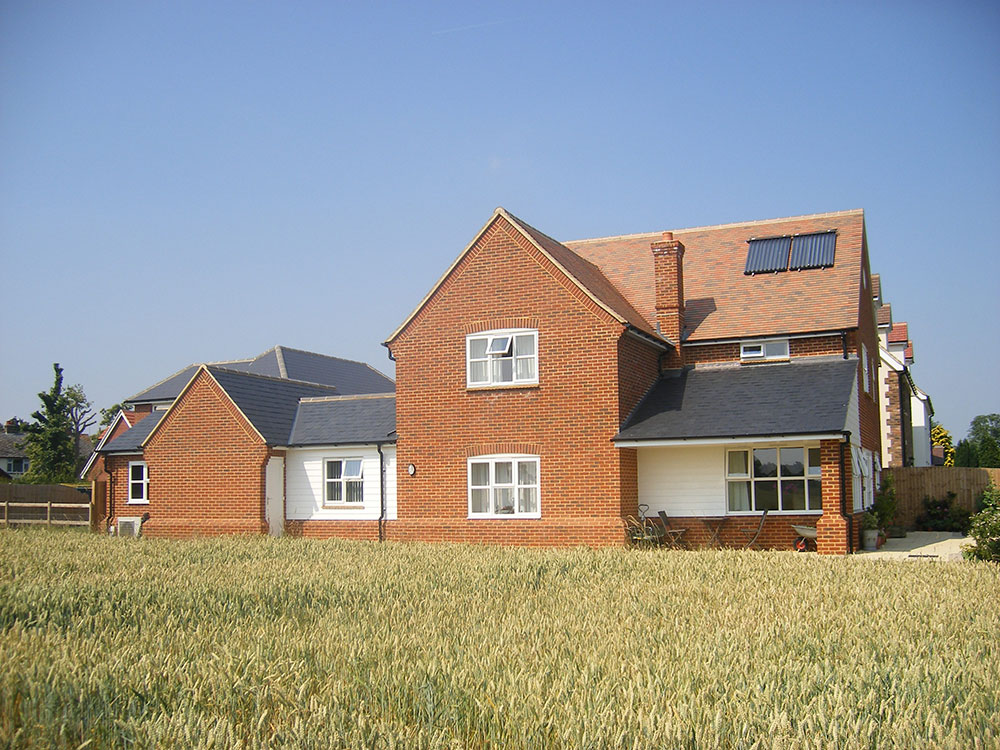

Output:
xmin=465 ymin=330 xmax=538 ymax=387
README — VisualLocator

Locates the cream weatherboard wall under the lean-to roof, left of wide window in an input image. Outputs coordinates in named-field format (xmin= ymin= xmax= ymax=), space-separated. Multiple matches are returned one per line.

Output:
xmin=638 ymin=445 xmax=731 ymax=516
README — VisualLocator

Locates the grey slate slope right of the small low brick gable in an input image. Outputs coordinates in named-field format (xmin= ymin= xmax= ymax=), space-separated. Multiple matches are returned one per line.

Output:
xmin=207 ymin=365 xmax=337 ymax=445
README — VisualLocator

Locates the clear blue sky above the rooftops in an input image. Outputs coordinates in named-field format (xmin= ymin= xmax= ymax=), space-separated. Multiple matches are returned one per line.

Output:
xmin=0 ymin=1 xmax=1000 ymax=438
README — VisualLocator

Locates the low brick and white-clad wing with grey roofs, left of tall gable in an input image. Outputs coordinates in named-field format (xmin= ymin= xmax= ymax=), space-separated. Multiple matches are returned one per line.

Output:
xmin=87 ymin=347 xmax=395 ymax=538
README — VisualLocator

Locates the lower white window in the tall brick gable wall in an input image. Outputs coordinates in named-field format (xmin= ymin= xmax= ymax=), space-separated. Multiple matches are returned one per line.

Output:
xmin=469 ymin=456 xmax=541 ymax=518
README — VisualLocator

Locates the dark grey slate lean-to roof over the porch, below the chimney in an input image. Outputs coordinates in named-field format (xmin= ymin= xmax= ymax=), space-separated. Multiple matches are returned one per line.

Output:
xmin=615 ymin=358 xmax=858 ymax=441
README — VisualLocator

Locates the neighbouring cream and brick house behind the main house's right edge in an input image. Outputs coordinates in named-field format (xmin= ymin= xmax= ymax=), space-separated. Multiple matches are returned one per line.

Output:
xmin=872 ymin=274 xmax=934 ymax=467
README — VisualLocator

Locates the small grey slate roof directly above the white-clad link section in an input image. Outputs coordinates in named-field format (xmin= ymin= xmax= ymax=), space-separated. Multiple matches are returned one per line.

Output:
xmin=288 ymin=393 xmax=396 ymax=445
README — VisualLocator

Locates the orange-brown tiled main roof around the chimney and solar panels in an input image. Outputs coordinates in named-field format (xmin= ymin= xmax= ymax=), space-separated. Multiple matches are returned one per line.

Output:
xmin=563 ymin=210 xmax=864 ymax=341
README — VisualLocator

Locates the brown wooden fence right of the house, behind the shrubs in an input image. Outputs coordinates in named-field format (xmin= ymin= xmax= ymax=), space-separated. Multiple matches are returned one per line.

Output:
xmin=883 ymin=466 xmax=1000 ymax=529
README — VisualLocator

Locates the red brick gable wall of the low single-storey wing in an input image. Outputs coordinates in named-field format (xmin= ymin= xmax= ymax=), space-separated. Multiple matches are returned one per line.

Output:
xmin=122 ymin=371 xmax=270 ymax=537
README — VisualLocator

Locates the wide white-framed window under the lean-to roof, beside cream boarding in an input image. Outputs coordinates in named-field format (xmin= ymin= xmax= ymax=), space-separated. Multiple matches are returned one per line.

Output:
xmin=726 ymin=446 xmax=823 ymax=513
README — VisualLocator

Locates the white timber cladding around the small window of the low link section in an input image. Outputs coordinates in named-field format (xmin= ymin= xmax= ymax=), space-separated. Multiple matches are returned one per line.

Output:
xmin=285 ymin=445 xmax=396 ymax=521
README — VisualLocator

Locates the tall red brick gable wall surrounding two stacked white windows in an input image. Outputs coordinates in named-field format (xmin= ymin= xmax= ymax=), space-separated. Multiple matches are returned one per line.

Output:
xmin=387 ymin=217 xmax=656 ymax=545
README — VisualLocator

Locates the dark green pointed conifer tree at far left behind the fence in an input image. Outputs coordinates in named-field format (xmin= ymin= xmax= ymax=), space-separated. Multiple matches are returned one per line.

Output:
xmin=21 ymin=362 xmax=77 ymax=484
